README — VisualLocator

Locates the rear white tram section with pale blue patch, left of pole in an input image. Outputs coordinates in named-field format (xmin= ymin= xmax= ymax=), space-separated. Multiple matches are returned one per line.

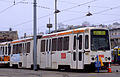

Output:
xmin=10 ymin=38 xmax=33 ymax=68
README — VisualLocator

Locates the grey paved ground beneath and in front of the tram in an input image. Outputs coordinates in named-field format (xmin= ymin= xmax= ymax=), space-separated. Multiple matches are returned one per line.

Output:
xmin=0 ymin=66 xmax=120 ymax=77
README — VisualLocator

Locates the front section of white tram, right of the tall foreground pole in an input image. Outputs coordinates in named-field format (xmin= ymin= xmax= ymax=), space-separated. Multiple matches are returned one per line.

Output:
xmin=37 ymin=27 xmax=111 ymax=69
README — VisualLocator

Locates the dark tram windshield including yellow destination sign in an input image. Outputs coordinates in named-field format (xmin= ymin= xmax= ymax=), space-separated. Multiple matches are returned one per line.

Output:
xmin=91 ymin=29 xmax=110 ymax=50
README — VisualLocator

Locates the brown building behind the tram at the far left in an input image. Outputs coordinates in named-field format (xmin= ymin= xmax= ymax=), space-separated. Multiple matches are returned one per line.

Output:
xmin=0 ymin=29 xmax=18 ymax=43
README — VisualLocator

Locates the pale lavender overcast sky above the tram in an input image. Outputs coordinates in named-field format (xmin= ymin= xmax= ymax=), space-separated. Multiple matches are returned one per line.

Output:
xmin=0 ymin=0 xmax=120 ymax=37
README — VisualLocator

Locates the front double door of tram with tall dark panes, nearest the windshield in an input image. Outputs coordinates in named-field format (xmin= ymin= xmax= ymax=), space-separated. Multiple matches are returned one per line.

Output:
xmin=72 ymin=33 xmax=84 ymax=69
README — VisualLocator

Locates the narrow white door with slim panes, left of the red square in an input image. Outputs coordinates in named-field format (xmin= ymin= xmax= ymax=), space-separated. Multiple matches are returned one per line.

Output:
xmin=46 ymin=39 xmax=52 ymax=68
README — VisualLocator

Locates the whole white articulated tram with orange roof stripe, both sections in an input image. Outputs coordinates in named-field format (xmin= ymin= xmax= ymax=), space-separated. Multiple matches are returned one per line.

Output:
xmin=0 ymin=27 xmax=111 ymax=70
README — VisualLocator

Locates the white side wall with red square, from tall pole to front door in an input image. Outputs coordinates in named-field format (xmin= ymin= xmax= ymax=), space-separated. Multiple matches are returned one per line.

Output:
xmin=38 ymin=35 xmax=74 ymax=69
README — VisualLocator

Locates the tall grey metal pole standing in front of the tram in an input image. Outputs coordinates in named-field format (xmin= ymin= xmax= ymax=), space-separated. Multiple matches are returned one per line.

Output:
xmin=33 ymin=0 xmax=37 ymax=71
